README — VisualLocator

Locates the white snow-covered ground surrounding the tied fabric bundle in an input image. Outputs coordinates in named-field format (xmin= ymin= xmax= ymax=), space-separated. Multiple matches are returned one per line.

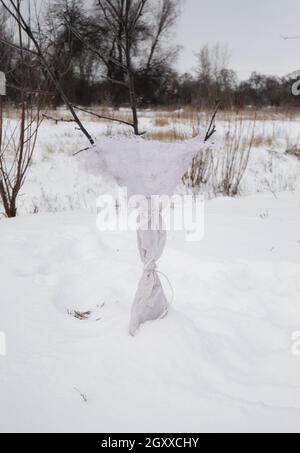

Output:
xmin=0 ymin=108 xmax=300 ymax=433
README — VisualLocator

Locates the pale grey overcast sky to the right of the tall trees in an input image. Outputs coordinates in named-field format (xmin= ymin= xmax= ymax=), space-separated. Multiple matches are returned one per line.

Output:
xmin=176 ymin=0 xmax=300 ymax=79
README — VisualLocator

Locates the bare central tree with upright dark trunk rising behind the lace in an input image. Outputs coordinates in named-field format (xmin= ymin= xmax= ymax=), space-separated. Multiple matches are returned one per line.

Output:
xmin=62 ymin=0 xmax=179 ymax=129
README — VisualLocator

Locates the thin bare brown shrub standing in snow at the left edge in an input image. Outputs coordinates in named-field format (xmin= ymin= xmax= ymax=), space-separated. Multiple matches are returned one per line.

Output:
xmin=0 ymin=0 xmax=47 ymax=217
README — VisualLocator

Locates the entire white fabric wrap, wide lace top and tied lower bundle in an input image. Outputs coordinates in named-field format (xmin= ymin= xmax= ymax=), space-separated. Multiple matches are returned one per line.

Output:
xmin=80 ymin=137 xmax=211 ymax=335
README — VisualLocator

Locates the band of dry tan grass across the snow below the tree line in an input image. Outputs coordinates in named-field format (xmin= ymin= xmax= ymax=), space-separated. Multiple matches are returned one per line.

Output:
xmin=4 ymin=105 xmax=300 ymax=149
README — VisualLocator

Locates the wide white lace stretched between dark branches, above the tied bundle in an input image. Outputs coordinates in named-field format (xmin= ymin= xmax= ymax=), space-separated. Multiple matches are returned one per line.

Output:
xmin=79 ymin=136 xmax=207 ymax=197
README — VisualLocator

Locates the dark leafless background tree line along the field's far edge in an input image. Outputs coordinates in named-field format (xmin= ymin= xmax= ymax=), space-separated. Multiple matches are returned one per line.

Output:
xmin=0 ymin=0 xmax=300 ymax=108
